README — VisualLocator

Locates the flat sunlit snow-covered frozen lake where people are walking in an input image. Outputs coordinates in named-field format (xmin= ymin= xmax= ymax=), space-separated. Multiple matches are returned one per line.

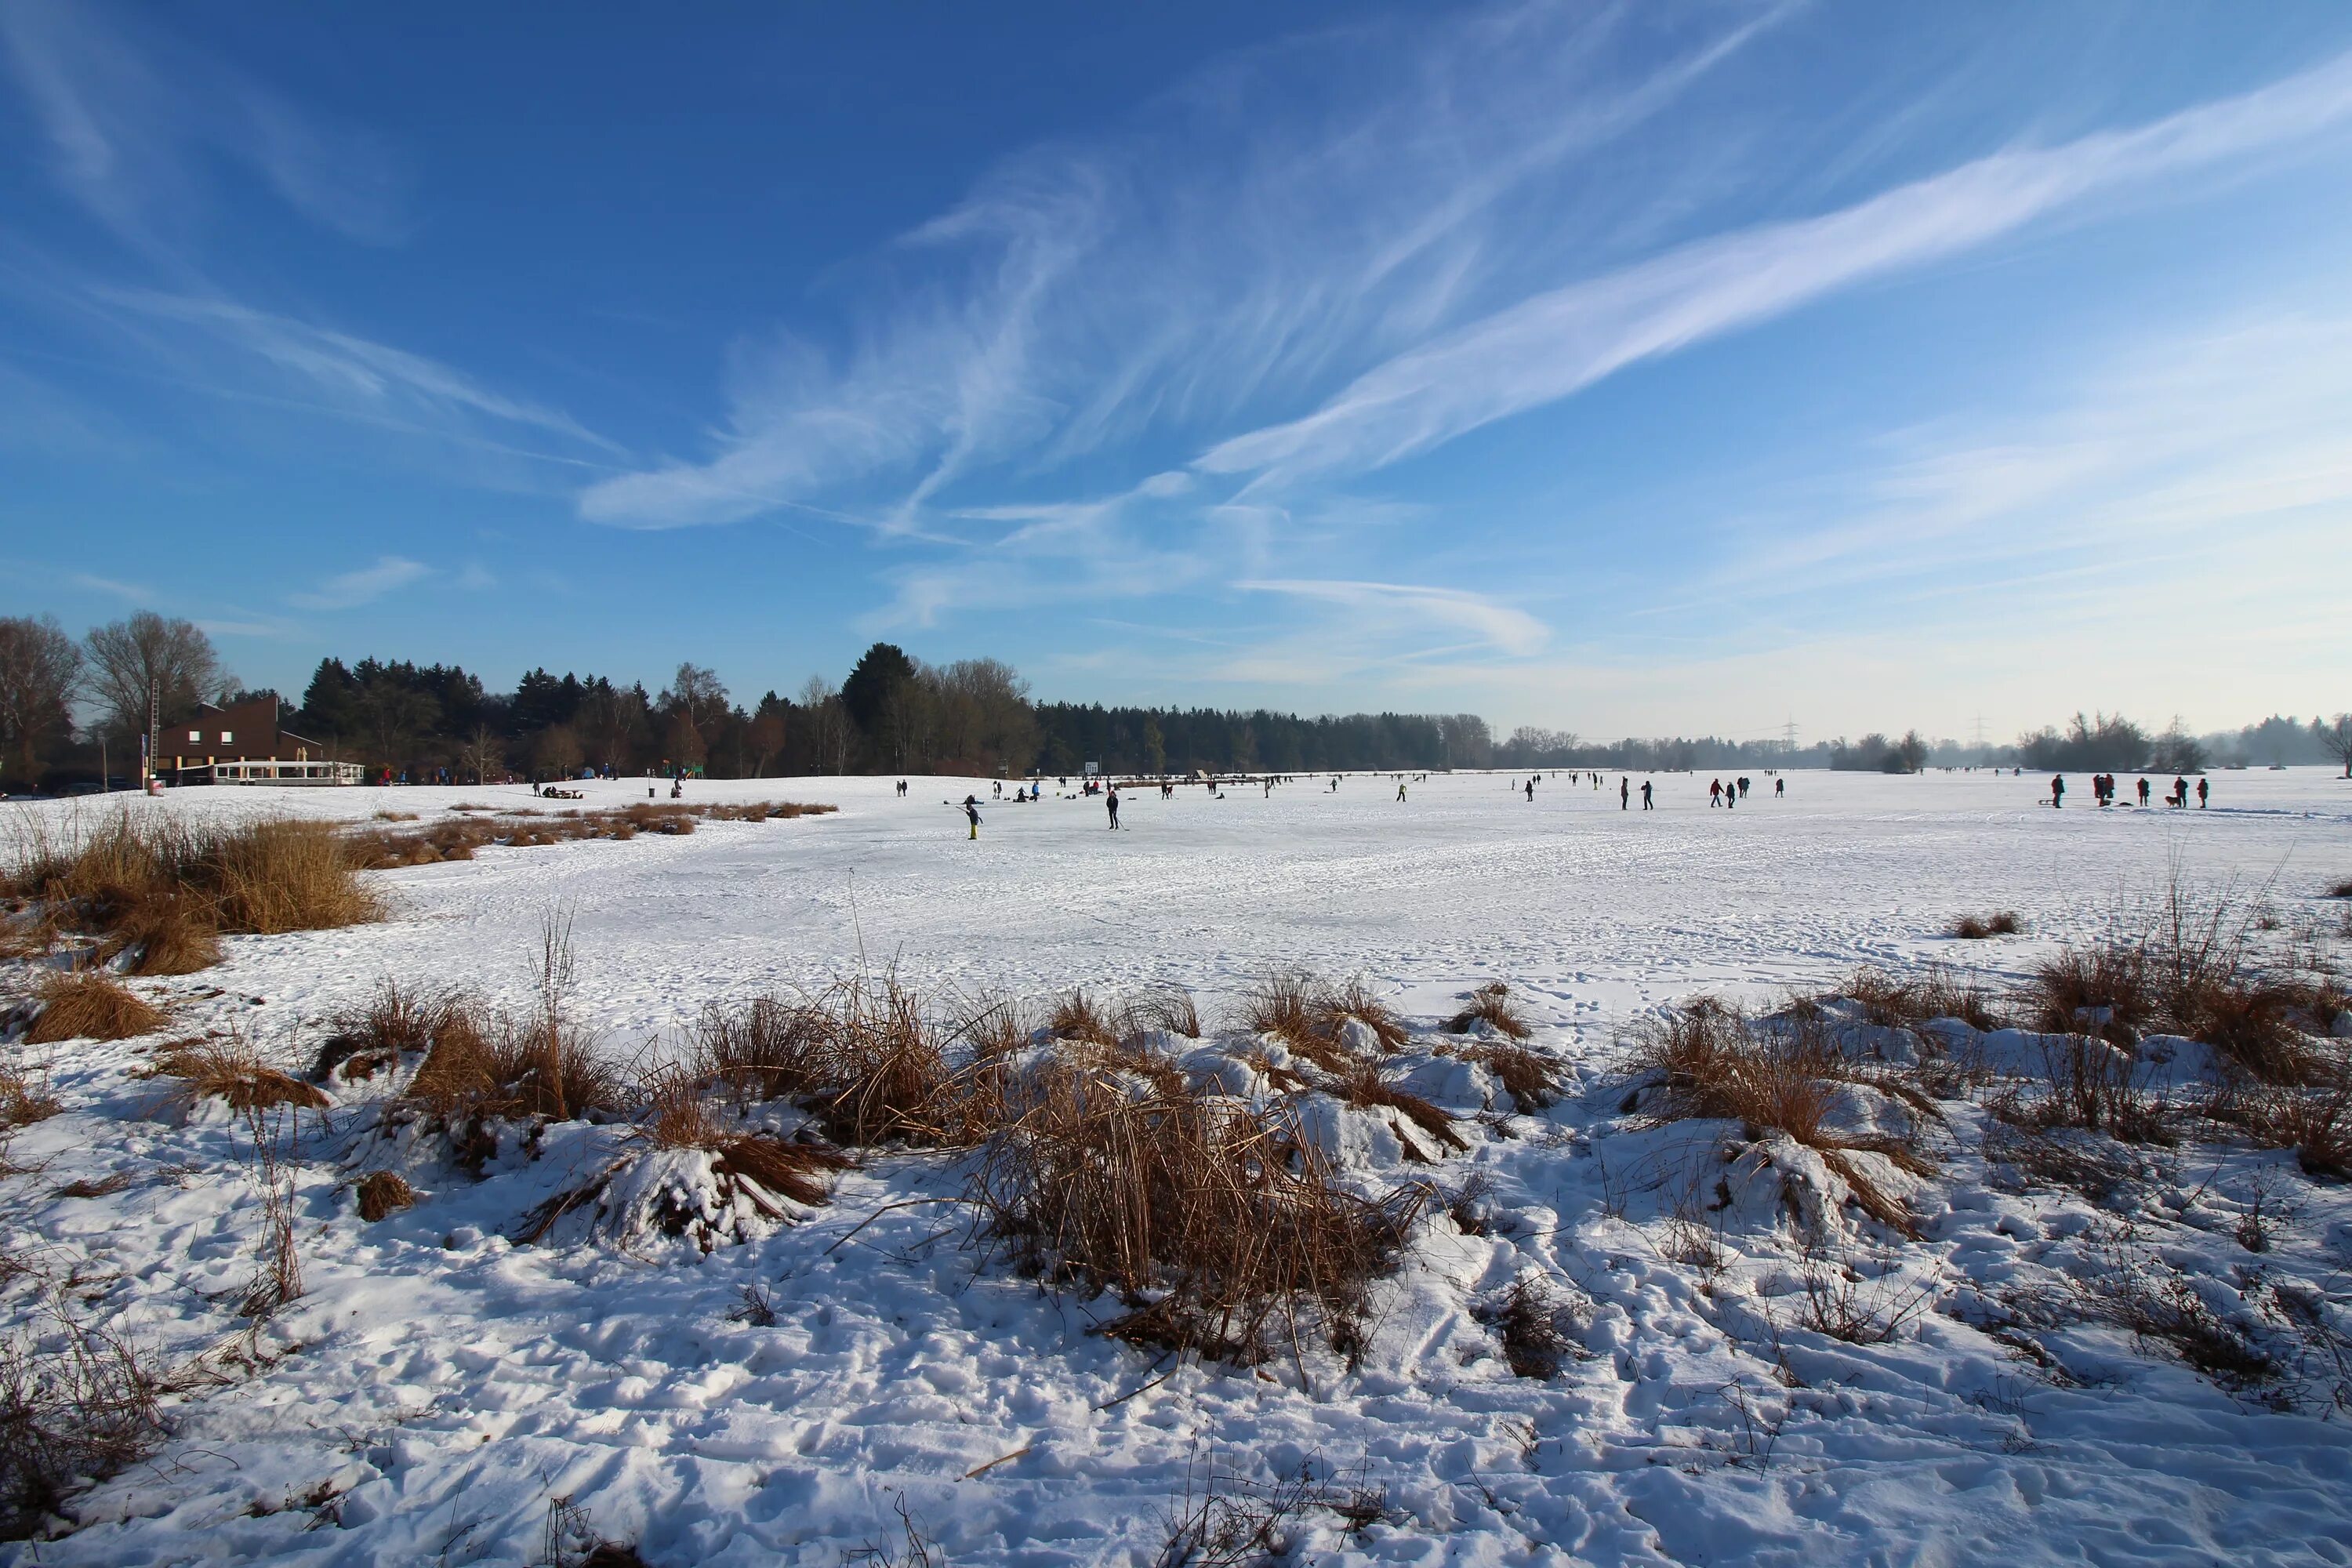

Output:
xmin=23 ymin=769 xmax=2352 ymax=1036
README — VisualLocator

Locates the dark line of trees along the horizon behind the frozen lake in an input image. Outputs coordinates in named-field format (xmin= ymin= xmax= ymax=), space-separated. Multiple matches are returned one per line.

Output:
xmin=0 ymin=614 xmax=2352 ymax=789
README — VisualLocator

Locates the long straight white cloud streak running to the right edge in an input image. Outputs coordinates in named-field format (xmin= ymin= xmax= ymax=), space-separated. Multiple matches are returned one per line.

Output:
xmin=1200 ymin=56 xmax=2352 ymax=480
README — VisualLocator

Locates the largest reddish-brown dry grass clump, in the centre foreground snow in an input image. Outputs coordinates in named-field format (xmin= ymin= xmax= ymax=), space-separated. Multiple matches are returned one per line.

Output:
xmin=967 ymin=1055 xmax=1423 ymax=1363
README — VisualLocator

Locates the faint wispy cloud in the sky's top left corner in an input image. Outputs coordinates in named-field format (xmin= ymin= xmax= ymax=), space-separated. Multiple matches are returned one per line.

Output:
xmin=0 ymin=0 xmax=405 ymax=254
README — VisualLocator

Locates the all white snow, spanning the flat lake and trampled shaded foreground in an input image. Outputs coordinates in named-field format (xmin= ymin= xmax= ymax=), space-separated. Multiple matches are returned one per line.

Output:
xmin=0 ymin=769 xmax=2352 ymax=1568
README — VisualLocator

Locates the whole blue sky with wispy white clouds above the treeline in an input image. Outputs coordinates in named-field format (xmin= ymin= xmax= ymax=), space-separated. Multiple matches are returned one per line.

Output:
xmin=0 ymin=0 xmax=2352 ymax=739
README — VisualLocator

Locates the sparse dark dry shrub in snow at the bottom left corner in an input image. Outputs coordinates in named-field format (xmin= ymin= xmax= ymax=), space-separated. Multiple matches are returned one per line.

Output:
xmin=0 ymin=1307 xmax=162 ymax=1540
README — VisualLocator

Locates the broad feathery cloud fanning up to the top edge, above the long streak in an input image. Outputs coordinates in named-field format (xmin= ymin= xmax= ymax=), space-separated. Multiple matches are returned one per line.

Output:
xmin=581 ymin=5 xmax=1785 ymax=532
